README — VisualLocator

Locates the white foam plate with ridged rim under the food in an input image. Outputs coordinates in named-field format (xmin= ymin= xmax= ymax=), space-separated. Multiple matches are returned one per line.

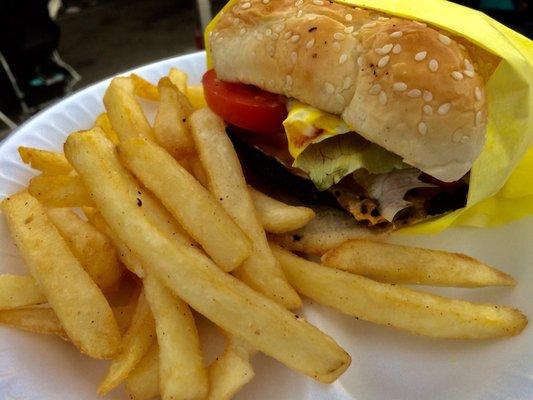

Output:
xmin=0 ymin=53 xmax=533 ymax=400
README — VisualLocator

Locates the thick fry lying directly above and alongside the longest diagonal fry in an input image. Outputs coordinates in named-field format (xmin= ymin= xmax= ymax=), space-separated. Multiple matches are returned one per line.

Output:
xmin=119 ymin=138 xmax=252 ymax=271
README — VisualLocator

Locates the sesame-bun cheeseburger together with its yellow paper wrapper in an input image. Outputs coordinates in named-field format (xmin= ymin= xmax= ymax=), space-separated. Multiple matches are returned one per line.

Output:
xmin=203 ymin=0 xmax=533 ymax=236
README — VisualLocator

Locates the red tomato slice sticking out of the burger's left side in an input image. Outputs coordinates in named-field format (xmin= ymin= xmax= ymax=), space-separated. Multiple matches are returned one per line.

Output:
xmin=202 ymin=69 xmax=287 ymax=133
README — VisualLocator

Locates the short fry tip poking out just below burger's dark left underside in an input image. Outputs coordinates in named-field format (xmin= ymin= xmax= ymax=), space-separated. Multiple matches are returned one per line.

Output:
xmin=248 ymin=186 xmax=315 ymax=233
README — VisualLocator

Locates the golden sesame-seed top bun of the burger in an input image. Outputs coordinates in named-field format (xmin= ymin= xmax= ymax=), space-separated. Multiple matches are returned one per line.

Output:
xmin=209 ymin=0 xmax=487 ymax=182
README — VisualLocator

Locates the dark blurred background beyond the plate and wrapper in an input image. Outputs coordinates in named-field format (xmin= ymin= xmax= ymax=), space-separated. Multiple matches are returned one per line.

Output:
xmin=0 ymin=0 xmax=533 ymax=140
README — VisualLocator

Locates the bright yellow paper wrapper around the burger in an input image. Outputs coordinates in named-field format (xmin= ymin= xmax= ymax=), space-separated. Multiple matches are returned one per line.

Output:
xmin=205 ymin=0 xmax=533 ymax=233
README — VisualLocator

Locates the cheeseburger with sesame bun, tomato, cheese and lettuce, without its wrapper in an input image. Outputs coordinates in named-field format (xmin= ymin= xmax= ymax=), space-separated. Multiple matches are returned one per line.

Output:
xmin=203 ymin=0 xmax=488 ymax=227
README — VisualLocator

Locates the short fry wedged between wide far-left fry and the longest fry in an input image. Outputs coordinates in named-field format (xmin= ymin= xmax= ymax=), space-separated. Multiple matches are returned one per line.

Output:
xmin=48 ymin=208 xmax=124 ymax=290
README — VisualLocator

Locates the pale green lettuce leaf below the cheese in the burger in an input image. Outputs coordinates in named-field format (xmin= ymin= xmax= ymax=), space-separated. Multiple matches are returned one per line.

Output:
xmin=293 ymin=132 xmax=408 ymax=190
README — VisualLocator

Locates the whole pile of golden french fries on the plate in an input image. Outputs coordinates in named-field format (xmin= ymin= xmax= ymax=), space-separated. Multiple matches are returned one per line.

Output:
xmin=0 ymin=69 xmax=527 ymax=400
